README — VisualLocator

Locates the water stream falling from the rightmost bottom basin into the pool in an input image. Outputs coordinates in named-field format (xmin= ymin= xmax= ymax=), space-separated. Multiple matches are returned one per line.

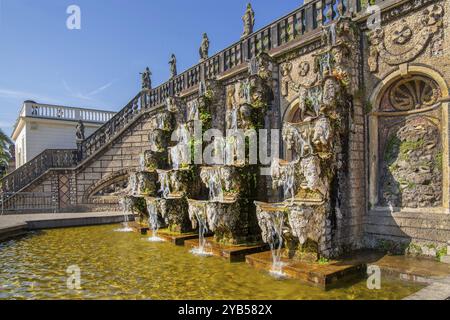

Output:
xmin=269 ymin=212 xmax=285 ymax=277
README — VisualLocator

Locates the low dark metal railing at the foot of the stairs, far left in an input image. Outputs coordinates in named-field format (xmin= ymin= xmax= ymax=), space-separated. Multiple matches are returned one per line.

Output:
xmin=0 ymin=192 xmax=58 ymax=215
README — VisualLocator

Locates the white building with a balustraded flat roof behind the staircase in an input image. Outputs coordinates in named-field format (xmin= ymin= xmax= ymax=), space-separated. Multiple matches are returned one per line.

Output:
xmin=11 ymin=101 xmax=115 ymax=168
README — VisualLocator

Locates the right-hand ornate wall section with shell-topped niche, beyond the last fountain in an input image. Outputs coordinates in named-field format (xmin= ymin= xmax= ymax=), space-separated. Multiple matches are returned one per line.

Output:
xmin=363 ymin=0 xmax=450 ymax=255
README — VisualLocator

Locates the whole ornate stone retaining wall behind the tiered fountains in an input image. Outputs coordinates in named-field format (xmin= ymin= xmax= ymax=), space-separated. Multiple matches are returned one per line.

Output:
xmin=7 ymin=0 xmax=450 ymax=256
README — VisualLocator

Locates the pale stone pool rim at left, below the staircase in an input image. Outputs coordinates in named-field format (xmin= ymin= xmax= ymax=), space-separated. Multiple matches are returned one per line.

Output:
xmin=0 ymin=212 xmax=134 ymax=241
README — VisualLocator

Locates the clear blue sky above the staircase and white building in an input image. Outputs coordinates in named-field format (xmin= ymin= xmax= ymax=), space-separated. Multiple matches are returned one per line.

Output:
xmin=0 ymin=0 xmax=302 ymax=134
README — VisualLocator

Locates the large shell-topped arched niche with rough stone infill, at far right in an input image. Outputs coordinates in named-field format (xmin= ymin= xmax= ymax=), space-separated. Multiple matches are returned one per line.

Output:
xmin=368 ymin=66 xmax=449 ymax=212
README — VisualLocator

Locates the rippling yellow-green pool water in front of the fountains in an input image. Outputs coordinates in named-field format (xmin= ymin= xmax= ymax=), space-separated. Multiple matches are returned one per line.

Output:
xmin=0 ymin=225 xmax=421 ymax=300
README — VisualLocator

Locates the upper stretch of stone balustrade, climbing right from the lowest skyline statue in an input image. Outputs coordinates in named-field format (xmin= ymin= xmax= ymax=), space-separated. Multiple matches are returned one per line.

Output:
xmin=142 ymin=0 xmax=360 ymax=106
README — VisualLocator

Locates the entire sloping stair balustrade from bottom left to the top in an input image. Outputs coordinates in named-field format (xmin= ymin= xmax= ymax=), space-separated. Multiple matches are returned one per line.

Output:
xmin=1 ymin=0 xmax=372 ymax=192
